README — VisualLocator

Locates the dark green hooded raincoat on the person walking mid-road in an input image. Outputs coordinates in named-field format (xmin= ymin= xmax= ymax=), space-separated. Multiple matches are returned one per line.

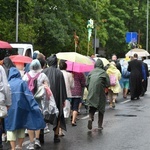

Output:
xmin=86 ymin=59 xmax=110 ymax=114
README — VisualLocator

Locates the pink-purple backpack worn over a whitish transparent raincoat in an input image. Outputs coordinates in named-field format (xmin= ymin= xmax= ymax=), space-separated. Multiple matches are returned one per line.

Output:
xmin=27 ymin=73 xmax=41 ymax=95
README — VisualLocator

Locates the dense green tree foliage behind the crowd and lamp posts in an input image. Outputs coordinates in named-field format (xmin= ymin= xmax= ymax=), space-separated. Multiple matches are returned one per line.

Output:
xmin=0 ymin=0 xmax=147 ymax=57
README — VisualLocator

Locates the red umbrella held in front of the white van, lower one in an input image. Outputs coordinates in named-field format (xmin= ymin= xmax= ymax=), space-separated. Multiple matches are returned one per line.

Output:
xmin=9 ymin=55 xmax=32 ymax=63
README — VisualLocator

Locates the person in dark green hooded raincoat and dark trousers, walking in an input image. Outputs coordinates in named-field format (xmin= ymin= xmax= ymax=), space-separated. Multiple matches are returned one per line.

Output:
xmin=86 ymin=59 xmax=110 ymax=130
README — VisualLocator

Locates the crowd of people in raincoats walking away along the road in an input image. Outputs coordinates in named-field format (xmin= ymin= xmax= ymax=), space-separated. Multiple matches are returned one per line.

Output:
xmin=0 ymin=53 xmax=149 ymax=150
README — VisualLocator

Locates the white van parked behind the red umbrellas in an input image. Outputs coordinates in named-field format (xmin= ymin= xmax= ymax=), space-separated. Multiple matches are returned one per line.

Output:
xmin=10 ymin=43 xmax=33 ymax=57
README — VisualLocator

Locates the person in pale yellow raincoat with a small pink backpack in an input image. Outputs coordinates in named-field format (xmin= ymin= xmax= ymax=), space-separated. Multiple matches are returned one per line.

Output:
xmin=106 ymin=61 xmax=121 ymax=108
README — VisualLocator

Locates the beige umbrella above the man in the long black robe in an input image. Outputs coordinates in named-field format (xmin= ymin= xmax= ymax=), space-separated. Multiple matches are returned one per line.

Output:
xmin=126 ymin=48 xmax=150 ymax=57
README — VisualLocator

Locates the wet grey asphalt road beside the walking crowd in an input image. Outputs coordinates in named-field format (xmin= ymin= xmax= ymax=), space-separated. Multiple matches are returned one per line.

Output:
xmin=2 ymin=79 xmax=150 ymax=150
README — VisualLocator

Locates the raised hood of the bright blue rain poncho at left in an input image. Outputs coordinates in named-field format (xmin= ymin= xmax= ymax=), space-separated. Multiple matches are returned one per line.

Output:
xmin=8 ymin=67 xmax=21 ymax=81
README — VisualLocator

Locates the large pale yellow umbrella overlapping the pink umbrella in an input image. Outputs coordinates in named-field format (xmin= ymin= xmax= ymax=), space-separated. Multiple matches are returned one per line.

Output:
xmin=56 ymin=52 xmax=93 ymax=65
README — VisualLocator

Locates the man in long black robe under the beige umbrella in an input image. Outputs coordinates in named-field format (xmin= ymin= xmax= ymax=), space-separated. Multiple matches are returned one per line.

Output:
xmin=128 ymin=54 xmax=143 ymax=100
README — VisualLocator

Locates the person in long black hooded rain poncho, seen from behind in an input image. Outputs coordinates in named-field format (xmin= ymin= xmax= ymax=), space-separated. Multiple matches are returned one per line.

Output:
xmin=43 ymin=55 xmax=67 ymax=143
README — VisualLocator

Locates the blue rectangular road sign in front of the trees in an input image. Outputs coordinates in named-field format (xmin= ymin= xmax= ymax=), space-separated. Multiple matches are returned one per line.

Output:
xmin=126 ymin=32 xmax=138 ymax=43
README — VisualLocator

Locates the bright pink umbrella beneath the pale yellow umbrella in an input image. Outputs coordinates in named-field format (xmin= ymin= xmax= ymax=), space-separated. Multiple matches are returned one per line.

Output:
xmin=66 ymin=61 xmax=94 ymax=72
